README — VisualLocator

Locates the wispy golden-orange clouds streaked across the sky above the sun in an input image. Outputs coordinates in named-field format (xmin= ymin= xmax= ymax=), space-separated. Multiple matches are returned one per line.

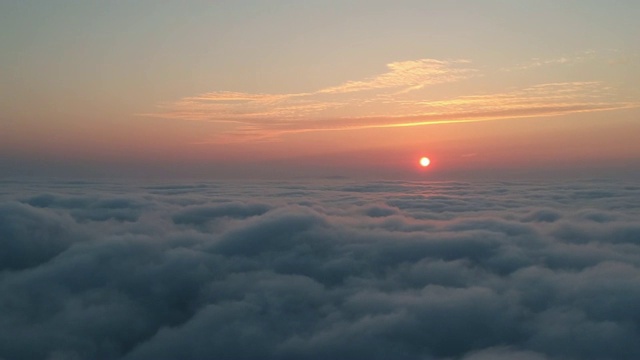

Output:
xmin=141 ymin=58 xmax=638 ymax=143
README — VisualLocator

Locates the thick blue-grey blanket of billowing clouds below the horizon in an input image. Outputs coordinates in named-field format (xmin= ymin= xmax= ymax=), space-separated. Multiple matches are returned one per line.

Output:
xmin=0 ymin=181 xmax=640 ymax=360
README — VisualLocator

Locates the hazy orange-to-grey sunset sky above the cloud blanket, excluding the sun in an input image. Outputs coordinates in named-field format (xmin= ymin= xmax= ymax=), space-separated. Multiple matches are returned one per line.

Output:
xmin=0 ymin=0 xmax=640 ymax=178
